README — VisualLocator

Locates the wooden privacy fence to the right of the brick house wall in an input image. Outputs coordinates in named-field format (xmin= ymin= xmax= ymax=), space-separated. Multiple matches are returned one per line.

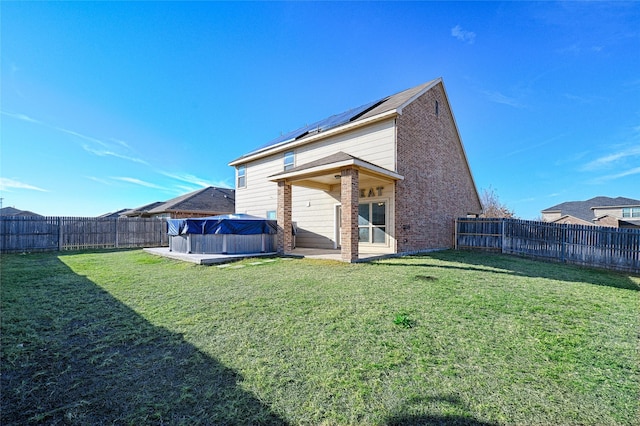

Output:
xmin=455 ymin=218 xmax=640 ymax=274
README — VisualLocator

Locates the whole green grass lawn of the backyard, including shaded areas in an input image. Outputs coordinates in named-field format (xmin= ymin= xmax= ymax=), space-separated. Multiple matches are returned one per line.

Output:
xmin=0 ymin=250 xmax=640 ymax=425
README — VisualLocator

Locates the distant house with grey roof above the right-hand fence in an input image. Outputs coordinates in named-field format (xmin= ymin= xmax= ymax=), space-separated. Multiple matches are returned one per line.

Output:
xmin=541 ymin=197 xmax=640 ymax=228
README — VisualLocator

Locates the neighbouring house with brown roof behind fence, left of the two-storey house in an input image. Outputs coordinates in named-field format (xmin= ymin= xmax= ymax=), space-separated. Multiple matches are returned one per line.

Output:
xmin=123 ymin=186 xmax=235 ymax=219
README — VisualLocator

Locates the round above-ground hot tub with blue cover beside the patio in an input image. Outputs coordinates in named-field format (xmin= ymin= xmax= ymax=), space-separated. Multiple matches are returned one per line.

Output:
xmin=167 ymin=214 xmax=278 ymax=254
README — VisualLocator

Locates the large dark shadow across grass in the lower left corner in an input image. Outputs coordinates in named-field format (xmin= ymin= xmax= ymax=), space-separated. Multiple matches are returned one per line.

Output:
xmin=0 ymin=255 xmax=286 ymax=425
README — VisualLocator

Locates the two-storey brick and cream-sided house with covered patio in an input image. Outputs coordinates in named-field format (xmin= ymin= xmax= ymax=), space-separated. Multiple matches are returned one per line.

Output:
xmin=229 ymin=78 xmax=482 ymax=262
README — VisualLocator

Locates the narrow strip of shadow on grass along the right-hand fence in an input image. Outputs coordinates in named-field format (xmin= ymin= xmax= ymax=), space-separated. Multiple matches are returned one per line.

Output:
xmin=388 ymin=250 xmax=640 ymax=291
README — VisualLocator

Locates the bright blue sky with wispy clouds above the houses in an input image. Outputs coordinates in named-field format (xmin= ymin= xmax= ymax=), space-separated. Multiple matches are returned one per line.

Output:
xmin=0 ymin=1 xmax=640 ymax=219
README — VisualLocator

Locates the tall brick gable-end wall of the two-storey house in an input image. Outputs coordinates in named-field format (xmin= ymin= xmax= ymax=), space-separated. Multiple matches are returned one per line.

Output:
xmin=395 ymin=84 xmax=481 ymax=253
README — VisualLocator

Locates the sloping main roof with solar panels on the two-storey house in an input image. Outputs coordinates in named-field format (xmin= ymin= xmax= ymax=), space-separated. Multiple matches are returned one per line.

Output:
xmin=229 ymin=78 xmax=442 ymax=166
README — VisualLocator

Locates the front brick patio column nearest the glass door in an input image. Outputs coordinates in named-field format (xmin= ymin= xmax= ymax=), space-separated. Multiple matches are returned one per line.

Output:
xmin=340 ymin=168 xmax=360 ymax=263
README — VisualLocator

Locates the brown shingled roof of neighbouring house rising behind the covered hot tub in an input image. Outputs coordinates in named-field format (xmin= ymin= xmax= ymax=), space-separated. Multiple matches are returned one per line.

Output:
xmin=148 ymin=186 xmax=235 ymax=214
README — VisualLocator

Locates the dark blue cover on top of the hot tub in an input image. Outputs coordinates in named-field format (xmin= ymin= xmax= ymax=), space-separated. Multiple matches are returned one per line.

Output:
xmin=167 ymin=214 xmax=278 ymax=235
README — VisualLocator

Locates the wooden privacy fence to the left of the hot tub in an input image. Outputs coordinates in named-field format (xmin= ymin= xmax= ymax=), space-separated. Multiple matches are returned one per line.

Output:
xmin=0 ymin=216 xmax=169 ymax=253
